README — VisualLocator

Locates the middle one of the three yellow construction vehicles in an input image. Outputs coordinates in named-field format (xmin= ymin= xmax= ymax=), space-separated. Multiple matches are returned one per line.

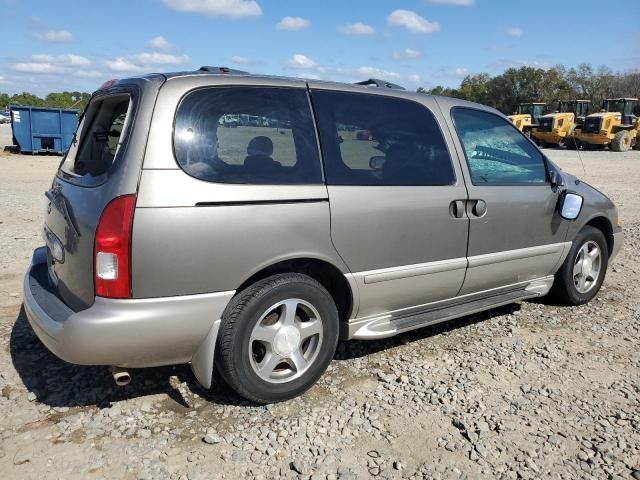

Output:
xmin=531 ymin=100 xmax=591 ymax=148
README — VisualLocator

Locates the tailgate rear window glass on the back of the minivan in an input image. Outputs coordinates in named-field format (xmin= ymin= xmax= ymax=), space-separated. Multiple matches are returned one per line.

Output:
xmin=60 ymin=93 xmax=131 ymax=182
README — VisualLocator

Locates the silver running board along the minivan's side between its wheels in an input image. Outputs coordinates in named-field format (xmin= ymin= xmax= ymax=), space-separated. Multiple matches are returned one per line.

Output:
xmin=348 ymin=289 xmax=546 ymax=340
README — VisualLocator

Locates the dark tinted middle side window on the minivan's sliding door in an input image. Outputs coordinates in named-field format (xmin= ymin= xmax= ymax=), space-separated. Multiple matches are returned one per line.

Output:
xmin=312 ymin=91 xmax=455 ymax=185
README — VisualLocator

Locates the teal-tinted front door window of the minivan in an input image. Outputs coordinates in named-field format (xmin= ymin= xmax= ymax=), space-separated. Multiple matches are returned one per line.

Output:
xmin=453 ymin=108 xmax=547 ymax=185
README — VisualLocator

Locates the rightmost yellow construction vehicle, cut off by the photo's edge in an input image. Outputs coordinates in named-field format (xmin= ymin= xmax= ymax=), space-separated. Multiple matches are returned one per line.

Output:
xmin=574 ymin=98 xmax=640 ymax=152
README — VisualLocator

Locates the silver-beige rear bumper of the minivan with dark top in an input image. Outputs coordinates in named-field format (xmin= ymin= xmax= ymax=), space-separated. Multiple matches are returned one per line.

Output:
xmin=24 ymin=247 xmax=234 ymax=382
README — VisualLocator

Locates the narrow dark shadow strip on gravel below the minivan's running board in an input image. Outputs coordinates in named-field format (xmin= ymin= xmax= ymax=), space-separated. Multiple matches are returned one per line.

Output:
xmin=334 ymin=303 xmax=520 ymax=360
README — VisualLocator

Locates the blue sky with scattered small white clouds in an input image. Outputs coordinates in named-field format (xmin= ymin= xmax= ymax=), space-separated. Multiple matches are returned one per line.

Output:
xmin=0 ymin=0 xmax=640 ymax=94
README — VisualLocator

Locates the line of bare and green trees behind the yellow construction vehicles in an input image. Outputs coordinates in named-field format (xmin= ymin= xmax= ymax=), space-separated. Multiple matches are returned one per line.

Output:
xmin=418 ymin=63 xmax=640 ymax=115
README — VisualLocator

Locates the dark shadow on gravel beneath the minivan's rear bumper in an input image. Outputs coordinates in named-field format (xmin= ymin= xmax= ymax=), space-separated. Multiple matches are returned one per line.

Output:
xmin=9 ymin=308 xmax=248 ymax=411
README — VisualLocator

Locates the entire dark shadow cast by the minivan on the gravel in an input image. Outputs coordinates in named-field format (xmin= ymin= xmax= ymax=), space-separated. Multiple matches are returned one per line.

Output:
xmin=10 ymin=304 xmax=520 ymax=411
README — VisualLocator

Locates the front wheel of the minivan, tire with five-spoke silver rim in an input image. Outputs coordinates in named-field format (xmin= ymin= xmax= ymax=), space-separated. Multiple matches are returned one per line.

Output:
xmin=551 ymin=225 xmax=609 ymax=305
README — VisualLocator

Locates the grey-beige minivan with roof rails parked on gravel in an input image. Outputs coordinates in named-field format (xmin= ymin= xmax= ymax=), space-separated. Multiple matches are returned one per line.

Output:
xmin=24 ymin=67 xmax=622 ymax=403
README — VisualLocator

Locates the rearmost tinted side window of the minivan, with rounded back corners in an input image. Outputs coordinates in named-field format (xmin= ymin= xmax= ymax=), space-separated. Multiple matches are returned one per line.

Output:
xmin=174 ymin=87 xmax=322 ymax=184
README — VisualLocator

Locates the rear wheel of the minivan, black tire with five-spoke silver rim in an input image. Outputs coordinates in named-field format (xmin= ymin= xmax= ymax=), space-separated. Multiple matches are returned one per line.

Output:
xmin=216 ymin=273 xmax=339 ymax=404
